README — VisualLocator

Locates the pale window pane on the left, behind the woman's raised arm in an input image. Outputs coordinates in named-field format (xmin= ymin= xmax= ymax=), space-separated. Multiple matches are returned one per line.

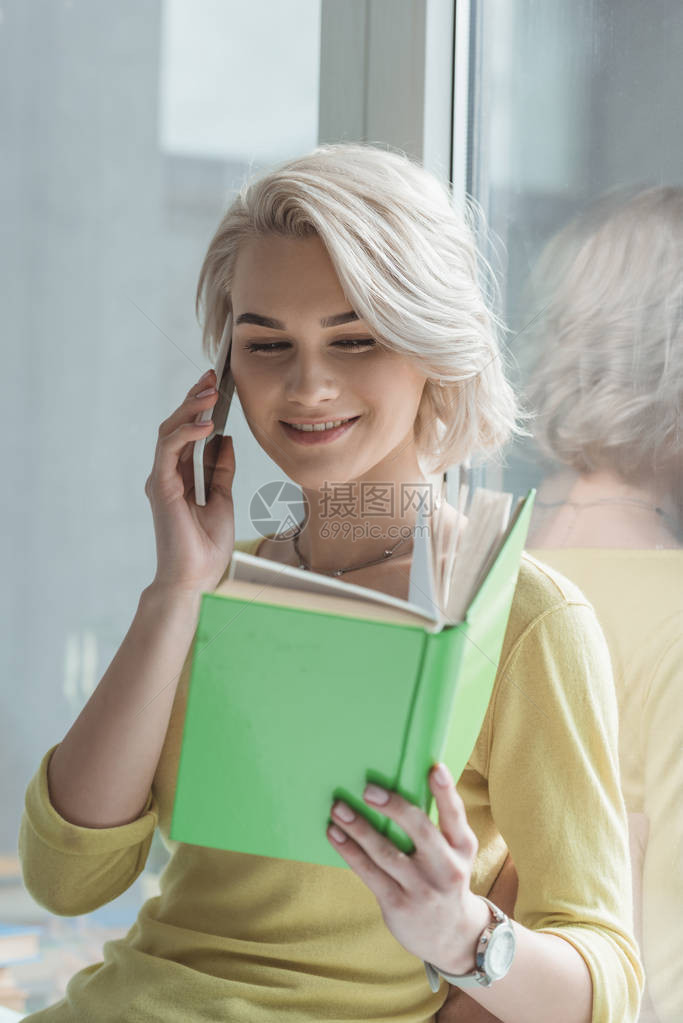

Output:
xmin=0 ymin=0 xmax=320 ymax=1011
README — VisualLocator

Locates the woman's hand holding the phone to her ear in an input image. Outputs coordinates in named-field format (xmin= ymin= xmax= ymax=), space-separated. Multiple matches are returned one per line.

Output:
xmin=144 ymin=369 xmax=235 ymax=592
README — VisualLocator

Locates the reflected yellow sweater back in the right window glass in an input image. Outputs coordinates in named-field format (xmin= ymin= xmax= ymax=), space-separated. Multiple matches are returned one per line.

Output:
xmin=533 ymin=547 xmax=683 ymax=1023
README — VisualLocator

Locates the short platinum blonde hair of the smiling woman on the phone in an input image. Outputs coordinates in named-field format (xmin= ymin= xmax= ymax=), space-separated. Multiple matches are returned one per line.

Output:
xmin=195 ymin=142 xmax=527 ymax=473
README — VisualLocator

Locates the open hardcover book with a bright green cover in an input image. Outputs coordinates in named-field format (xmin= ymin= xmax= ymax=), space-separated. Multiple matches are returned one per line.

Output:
xmin=170 ymin=487 xmax=536 ymax=870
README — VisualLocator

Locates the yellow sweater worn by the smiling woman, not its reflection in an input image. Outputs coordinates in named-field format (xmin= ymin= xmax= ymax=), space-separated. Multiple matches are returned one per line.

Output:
xmin=18 ymin=541 xmax=644 ymax=1023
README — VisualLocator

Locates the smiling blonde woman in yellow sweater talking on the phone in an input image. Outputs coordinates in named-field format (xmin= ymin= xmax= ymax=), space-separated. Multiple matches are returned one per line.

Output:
xmin=19 ymin=144 xmax=643 ymax=1023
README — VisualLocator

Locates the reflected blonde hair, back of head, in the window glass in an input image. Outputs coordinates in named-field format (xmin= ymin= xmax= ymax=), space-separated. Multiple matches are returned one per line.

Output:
xmin=520 ymin=187 xmax=683 ymax=483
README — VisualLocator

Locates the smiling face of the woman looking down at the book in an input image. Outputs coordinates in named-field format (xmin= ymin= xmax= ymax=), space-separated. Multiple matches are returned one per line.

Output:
xmin=231 ymin=235 xmax=426 ymax=489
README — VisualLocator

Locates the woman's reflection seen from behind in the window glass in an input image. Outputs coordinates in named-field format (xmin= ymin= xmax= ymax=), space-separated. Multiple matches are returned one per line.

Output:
xmin=519 ymin=186 xmax=683 ymax=1023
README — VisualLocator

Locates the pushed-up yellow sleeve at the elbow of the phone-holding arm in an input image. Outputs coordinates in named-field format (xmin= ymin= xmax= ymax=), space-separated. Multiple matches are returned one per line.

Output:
xmin=18 ymin=744 xmax=158 ymax=917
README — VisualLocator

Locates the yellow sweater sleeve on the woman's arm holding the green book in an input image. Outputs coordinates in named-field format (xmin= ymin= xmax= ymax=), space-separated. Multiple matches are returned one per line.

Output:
xmin=488 ymin=601 xmax=644 ymax=1023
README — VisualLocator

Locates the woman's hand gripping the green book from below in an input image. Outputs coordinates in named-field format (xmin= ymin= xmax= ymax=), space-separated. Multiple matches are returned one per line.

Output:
xmin=327 ymin=764 xmax=490 ymax=974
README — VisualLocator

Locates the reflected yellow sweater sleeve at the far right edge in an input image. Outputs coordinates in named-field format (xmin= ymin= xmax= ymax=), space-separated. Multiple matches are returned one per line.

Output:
xmin=642 ymin=626 xmax=683 ymax=1023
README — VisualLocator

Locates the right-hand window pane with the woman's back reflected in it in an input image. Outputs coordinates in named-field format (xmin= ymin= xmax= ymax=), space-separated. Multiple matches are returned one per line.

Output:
xmin=468 ymin=9 xmax=683 ymax=1020
